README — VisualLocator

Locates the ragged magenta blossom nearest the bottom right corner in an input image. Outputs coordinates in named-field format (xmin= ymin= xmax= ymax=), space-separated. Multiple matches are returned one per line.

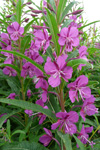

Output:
xmin=77 ymin=124 xmax=95 ymax=147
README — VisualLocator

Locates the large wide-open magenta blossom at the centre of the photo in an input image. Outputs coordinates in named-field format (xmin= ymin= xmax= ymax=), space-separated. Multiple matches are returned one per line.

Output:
xmin=44 ymin=55 xmax=73 ymax=87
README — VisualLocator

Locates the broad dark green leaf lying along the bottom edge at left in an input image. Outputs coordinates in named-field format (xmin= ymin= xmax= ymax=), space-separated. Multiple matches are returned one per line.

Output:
xmin=1 ymin=141 xmax=48 ymax=150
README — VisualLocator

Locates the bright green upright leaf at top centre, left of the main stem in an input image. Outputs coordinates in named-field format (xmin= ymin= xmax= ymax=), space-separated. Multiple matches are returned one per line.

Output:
xmin=46 ymin=9 xmax=60 ymax=56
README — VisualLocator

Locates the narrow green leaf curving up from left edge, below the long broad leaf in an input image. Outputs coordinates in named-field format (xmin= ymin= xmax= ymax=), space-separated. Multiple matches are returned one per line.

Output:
xmin=0 ymin=109 xmax=21 ymax=128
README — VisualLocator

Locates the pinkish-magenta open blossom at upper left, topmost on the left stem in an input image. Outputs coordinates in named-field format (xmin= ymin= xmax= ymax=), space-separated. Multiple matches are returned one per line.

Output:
xmin=7 ymin=22 xmax=24 ymax=41
